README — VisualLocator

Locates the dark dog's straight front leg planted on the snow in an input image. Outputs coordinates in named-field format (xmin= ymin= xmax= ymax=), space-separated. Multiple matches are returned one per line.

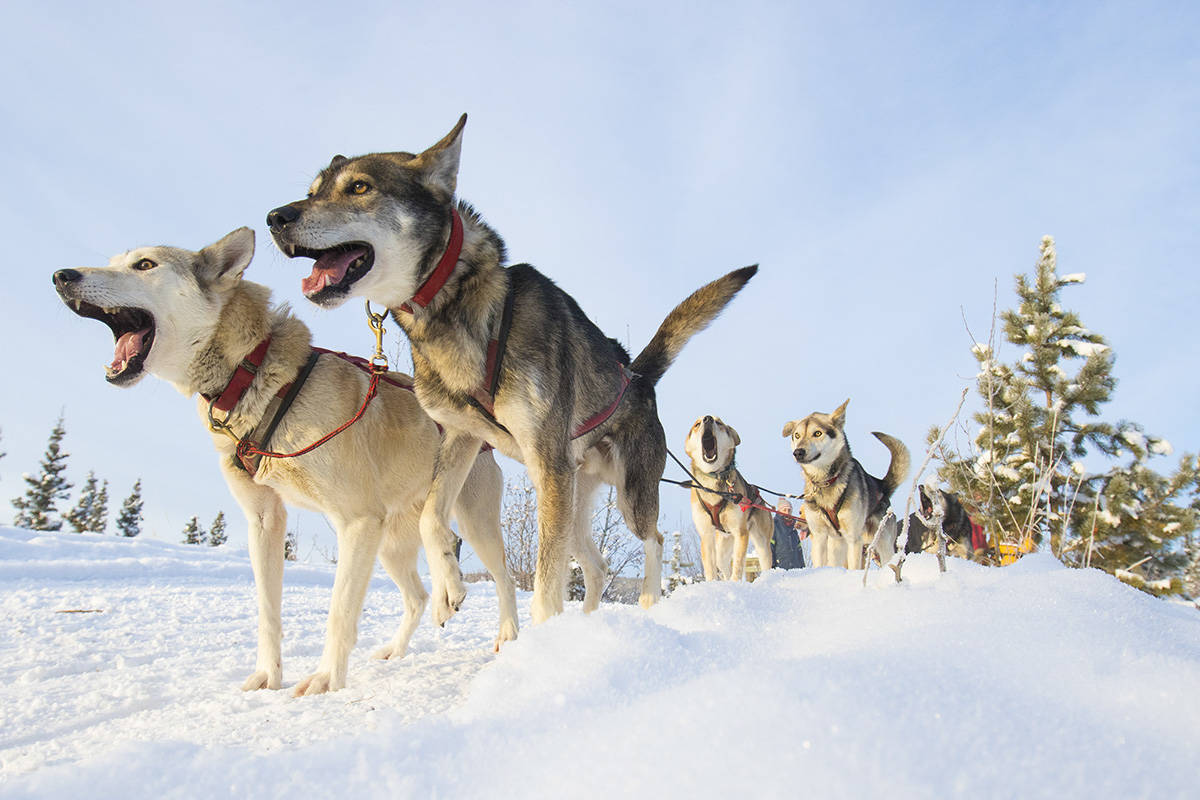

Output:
xmin=526 ymin=455 xmax=576 ymax=624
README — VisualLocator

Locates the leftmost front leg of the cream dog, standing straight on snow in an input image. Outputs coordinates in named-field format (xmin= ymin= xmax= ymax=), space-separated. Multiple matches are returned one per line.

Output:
xmin=221 ymin=472 xmax=288 ymax=691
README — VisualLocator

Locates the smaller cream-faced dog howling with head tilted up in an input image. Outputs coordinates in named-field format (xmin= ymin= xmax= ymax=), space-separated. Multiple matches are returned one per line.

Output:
xmin=684 ymin=416 xmax=774 ymax=581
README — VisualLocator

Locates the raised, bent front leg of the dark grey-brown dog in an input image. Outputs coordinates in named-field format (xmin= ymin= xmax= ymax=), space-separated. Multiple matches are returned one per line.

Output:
xmin=421 ymin=431 xmax=481 ymax=625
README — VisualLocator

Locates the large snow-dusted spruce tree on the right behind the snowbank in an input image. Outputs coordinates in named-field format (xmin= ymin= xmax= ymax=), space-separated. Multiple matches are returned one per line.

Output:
xmin=935 ymin=236 xmax=1183 ymax=571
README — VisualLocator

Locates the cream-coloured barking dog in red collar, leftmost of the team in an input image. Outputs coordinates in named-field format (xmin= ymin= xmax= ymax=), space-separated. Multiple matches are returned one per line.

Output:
xmin=54 ymin=228 xmax=517 ymax=696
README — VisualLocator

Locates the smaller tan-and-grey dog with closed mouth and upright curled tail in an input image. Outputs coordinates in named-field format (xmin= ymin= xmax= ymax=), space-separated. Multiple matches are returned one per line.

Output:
xmin=784 ymin=399 xmax=908 ymax=570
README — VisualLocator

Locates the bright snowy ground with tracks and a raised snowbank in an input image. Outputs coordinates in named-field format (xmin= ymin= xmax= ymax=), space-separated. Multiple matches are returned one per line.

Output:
xmin=0 ymin=528 xmax=1200 ymax=800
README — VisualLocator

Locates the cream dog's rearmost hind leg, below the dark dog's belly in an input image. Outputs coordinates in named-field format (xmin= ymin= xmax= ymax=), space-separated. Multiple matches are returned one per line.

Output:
xmin=454 ymin=455 xmax=517 ymax=651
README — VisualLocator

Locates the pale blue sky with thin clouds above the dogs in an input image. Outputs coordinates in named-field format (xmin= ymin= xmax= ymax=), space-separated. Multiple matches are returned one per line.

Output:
xmin=0 ymin=1 xmax=1200 ymax=563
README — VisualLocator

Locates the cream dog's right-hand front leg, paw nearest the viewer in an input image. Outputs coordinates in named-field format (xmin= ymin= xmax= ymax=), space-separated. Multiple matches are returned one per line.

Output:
xmin=292 ymin=517 xmax=383 ymax=697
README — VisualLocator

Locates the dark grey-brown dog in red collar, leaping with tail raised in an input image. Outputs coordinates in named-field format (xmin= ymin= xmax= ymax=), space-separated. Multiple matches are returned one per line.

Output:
xmin=266 ymin=114 xmax=757 ymax=621
